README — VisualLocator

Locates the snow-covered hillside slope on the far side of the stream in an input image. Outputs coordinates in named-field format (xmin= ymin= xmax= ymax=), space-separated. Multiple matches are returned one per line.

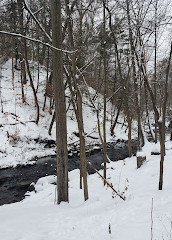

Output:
xmin=0 ymin=60 xmax=131 ymax=168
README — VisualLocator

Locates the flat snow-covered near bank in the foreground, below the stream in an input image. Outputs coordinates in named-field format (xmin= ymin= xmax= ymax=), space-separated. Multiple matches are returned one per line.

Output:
xmin=0 ymin=141 xmax=172 ymax=240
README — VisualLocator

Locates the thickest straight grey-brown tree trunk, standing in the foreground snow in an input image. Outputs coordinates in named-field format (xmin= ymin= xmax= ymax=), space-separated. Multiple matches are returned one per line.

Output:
xmin=51 ymin=0 xmax=68 ymax=204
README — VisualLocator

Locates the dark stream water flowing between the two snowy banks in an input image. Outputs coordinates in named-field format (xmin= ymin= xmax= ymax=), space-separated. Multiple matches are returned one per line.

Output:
xmin=0 ymin=141 xmax=137 ymax=205
